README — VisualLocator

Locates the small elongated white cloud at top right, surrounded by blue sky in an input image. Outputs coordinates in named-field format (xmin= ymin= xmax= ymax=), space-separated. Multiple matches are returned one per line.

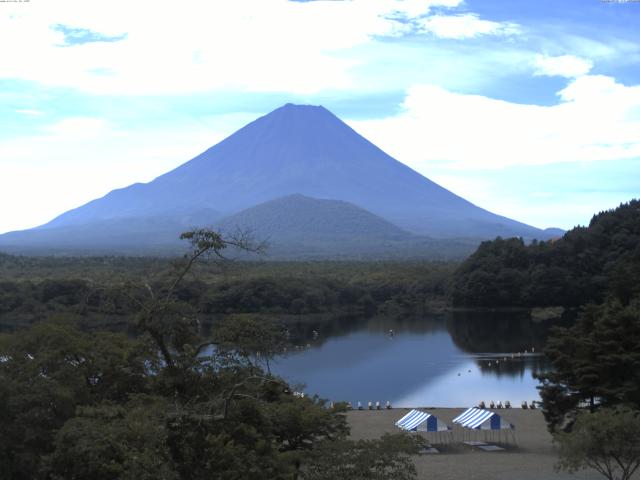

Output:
xmin=419 ymin=13 xmax=520 ymax=39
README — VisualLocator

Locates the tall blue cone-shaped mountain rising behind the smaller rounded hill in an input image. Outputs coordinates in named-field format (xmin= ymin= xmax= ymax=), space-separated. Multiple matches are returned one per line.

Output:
xmin=0 ymin=104 xmax=548 ymax=256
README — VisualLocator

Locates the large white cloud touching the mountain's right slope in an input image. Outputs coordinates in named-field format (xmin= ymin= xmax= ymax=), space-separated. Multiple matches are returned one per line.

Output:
xmin=349 ymin=75 xmax=640 ymax=172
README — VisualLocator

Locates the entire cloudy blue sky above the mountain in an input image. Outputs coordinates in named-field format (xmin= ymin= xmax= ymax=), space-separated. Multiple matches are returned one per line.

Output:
xmin=0 ymin=0 xmax=640 ymax=232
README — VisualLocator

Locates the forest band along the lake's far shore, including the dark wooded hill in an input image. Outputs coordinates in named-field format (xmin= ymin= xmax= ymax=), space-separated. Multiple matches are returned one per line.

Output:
xmin=5 ymin=200 xmax=640 ymax=329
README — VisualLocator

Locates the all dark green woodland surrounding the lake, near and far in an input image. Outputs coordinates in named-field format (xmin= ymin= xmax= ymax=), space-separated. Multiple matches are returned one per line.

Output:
xmin=0 ymin=200 xmax=640 ymax=480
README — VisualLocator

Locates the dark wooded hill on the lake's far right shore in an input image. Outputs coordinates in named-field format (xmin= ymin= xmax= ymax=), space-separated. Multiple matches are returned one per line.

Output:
xmin=452 ymin=200 xmax=640 ymax=307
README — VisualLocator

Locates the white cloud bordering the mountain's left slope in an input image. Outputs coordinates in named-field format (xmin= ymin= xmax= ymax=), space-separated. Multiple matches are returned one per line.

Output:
xmin=0 ymin=113 xmax=258 ymax=233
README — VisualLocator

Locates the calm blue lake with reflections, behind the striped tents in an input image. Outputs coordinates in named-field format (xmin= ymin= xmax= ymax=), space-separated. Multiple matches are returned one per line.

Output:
xmin=273 ymin=312 xmax=548 ymax=407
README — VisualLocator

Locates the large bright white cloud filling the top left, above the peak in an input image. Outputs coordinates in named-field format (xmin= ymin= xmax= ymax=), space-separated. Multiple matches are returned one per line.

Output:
xmin=0 ymin=0 xmax=461 ymax=95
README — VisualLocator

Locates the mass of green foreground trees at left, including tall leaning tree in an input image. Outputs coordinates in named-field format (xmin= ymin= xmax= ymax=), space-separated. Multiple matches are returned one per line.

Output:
xmin=0 ymin=230 xmax=415 ymax=480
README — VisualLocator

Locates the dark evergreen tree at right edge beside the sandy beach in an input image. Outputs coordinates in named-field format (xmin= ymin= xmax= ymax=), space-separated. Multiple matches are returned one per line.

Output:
xmin=540 ymin=298 xmax=640 ymax=430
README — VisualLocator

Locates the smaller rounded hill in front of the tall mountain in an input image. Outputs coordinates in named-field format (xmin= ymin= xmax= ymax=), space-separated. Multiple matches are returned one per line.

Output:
xmin=216 ymin=194 xmax=473 ymax=259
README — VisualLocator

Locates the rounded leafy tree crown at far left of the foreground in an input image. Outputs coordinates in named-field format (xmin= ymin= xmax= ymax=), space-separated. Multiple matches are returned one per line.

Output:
xmin=0 ymin=320 xmax=147 ymax=479
